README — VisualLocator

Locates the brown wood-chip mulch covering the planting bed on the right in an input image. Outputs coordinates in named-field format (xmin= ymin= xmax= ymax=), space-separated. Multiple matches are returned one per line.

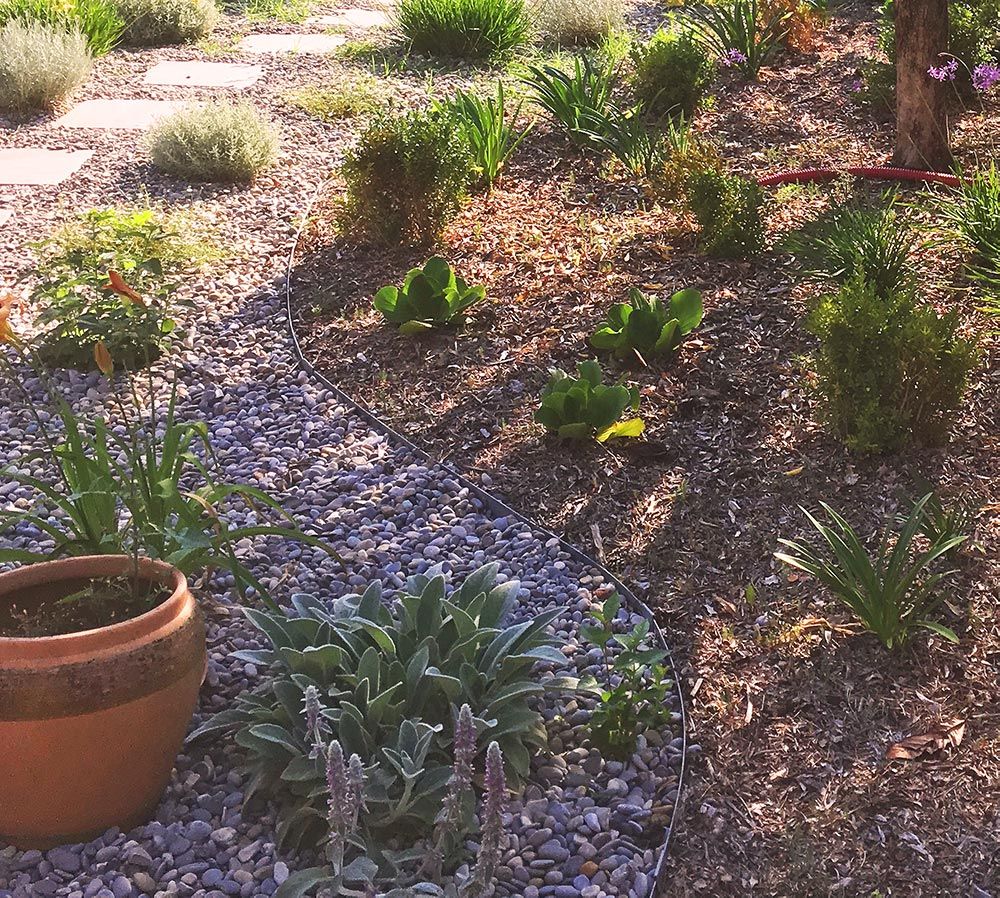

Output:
xmin=292 ymin=8 xmax=1000 ymax=896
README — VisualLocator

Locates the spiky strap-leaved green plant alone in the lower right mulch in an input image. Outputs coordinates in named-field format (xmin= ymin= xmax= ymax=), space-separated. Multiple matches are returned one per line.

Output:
xmin=775 ymin=494 xmax=966 ymax=649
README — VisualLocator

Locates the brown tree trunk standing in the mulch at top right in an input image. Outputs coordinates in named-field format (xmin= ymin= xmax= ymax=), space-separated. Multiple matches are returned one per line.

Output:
xmin=893 ymin=0 xmax=951 ymax=171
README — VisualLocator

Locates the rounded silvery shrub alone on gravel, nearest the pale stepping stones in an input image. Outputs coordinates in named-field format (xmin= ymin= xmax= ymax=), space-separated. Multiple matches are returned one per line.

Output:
xmin=148 ymin=100 xmax=278 ymax=183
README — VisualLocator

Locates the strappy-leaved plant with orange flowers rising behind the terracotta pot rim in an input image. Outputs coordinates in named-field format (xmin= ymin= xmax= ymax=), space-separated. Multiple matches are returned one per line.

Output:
xmin=0 ymin=284 xmax=335 ymax=612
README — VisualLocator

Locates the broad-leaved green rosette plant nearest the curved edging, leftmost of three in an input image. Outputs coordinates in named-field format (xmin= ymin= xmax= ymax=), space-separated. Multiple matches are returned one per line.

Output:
xmin=374 ymin=256 xmax=486 ymax=334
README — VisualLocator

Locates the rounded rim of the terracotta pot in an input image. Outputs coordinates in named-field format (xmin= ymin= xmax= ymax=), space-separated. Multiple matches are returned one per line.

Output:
xmin=0 ymin=555 xmax=194 ymax=663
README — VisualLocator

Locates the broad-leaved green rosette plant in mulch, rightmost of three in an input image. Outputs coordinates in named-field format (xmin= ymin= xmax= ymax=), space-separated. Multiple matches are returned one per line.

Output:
xmin=590 ymin=287 xmax=704 ymax=365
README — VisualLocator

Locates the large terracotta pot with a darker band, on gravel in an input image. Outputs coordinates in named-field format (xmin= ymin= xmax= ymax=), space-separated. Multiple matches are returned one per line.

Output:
xmin=0 ymin=555 xmax=206 ymax=848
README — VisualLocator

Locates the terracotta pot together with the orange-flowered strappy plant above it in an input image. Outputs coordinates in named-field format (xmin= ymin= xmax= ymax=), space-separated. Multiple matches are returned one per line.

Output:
xmin=0 ymin=278 xmax=332 ymax=847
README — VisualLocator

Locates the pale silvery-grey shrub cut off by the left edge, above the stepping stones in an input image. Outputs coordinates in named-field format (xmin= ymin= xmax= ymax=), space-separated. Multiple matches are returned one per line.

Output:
xmin=0 ymin=19 xmax=93 ymax=113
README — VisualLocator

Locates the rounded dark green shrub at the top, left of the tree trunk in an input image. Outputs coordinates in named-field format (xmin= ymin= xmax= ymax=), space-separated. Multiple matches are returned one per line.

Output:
xmin=632 ymin=29 xmax=715 ymax=118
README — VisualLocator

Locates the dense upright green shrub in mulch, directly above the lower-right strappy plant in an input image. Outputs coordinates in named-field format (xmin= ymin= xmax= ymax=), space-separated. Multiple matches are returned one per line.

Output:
xmin=808 ymin=277 xmax=978 ymax=452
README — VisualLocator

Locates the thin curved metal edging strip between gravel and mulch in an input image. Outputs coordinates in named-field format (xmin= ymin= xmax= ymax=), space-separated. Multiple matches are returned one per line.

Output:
xmin=284 ymin=181 xmax=688 ymax=894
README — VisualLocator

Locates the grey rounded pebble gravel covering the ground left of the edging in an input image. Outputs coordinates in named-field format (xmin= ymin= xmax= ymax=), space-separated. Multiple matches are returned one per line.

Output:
xmin=0 ymin=1 xmax=682 ymax=898
